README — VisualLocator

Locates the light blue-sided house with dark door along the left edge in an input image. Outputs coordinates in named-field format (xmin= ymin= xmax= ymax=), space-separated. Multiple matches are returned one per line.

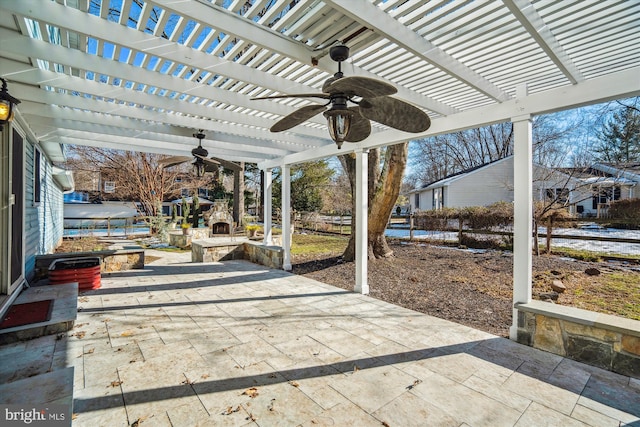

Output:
xmin=0 ymin=115 xmax=73 ymax=313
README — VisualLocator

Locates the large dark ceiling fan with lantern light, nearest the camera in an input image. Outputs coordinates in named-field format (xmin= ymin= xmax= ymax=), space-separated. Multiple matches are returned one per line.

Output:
xmin=251 ymin=45 xmax=431 ymax=148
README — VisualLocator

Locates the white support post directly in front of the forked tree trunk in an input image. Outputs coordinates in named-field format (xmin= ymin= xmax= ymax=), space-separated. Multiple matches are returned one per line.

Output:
xmin=351 ymin=150 xmax=369 ymax=295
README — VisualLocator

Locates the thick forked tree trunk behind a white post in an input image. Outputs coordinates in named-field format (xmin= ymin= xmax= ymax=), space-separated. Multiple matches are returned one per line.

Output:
xmin=340 ymin=142 xmax=409 ymax=261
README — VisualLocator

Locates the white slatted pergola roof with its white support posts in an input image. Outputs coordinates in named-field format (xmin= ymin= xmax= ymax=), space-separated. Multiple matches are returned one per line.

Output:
xmin=0 ymin=0 xmax=640 ymax=342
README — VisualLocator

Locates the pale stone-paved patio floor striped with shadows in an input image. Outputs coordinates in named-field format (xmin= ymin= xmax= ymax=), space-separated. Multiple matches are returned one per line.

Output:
xmin=0 ymin=249 xmax=640 ymax=426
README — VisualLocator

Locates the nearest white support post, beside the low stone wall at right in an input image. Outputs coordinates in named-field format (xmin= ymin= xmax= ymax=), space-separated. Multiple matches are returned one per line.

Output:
xmin=509 ymin=100 xmax=533 ymax=340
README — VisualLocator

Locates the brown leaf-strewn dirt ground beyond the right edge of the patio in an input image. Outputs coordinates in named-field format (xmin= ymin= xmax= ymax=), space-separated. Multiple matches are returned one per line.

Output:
xmin=292 ymin=242 xmax=640 ymax=336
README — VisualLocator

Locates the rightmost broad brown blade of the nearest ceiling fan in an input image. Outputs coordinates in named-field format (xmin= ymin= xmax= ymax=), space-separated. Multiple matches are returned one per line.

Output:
xmin=360 ymin=96 xmax=431 ymax=133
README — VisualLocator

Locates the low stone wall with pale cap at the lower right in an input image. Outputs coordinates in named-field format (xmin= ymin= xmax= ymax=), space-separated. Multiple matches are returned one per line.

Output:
xmin=516 ymin=301 xmax=640 ymax=378
